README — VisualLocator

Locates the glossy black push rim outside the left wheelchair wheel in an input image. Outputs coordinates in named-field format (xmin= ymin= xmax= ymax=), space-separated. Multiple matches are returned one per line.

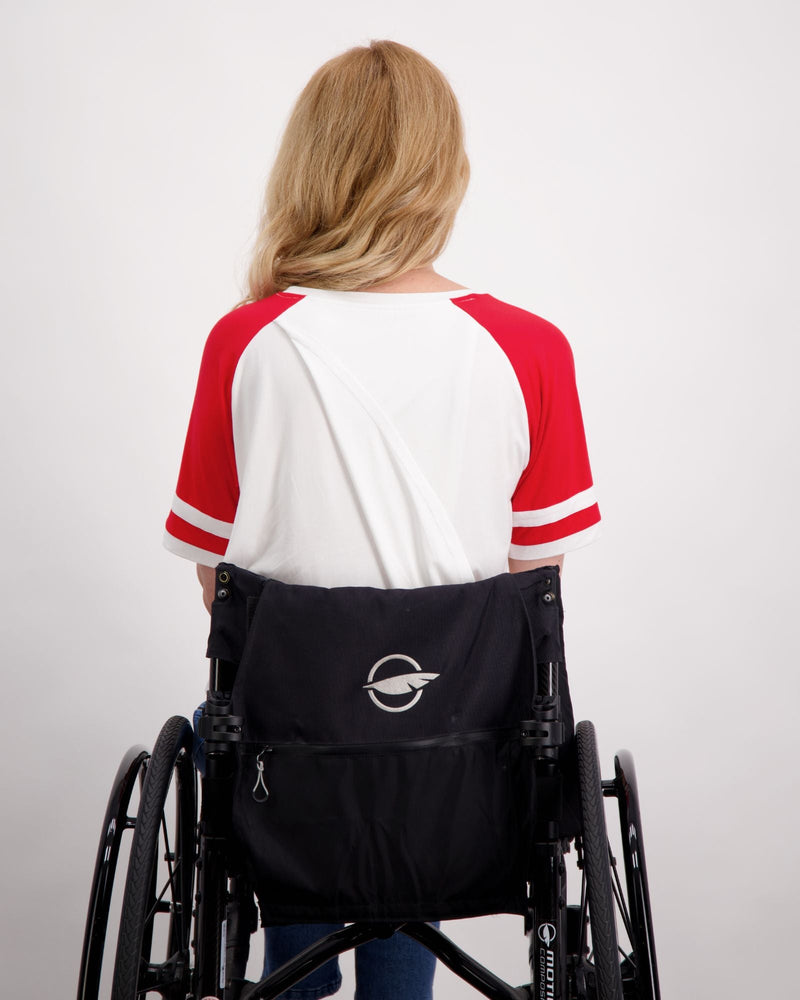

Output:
xmin=78 ymin=746 xmax=150 ymax=1000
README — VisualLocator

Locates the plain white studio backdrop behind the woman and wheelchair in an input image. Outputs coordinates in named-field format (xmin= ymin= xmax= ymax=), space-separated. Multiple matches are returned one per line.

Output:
xmin=0 ymin=0 xmax=800 ymax=1000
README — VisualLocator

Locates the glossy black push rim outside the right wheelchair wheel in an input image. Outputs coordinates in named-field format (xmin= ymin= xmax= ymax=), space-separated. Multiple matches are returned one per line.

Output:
xmin=614 ymin=750 xmax=661 ymax=1000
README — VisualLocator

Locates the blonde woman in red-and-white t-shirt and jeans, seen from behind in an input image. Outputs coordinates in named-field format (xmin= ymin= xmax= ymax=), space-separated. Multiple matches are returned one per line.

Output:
xmin=165 ymin=41 xmax=599 ymax=1000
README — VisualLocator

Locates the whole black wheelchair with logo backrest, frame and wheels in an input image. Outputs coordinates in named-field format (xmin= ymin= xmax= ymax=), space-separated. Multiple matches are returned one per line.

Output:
xmin=77 ymin=563 xmax=660 ymax=1000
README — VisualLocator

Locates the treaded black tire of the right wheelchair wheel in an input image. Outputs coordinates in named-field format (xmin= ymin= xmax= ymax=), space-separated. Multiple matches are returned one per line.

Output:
xmin=575 ymin=722 xmax=622 ymax=1000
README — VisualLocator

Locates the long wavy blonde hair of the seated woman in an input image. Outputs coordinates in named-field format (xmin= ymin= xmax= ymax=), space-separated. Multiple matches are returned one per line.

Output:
xmin=245 ymin=41 xmax=469 ymax=301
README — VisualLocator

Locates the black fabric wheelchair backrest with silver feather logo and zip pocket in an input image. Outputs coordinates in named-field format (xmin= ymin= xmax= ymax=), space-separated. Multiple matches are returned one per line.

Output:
xmin=208 ymin=564 xmax=572 ymax=923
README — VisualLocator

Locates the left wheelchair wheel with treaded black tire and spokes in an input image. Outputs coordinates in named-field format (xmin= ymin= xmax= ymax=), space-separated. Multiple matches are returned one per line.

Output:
xmin=111 ymin=715 xmax=197 ymax=1000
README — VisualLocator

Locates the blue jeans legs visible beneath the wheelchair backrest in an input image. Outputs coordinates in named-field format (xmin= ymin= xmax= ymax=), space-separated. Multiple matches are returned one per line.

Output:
xmin=264 ymin=923 xmax=438 ymax=1000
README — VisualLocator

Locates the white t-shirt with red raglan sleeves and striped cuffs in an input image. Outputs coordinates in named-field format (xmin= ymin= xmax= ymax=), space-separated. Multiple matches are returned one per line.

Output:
xmin=165 ymin=287 xmax=600 ymax=588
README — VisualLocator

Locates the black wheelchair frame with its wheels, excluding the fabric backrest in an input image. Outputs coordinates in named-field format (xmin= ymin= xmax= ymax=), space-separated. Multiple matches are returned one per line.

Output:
xmin=77 ymin=616 xmax=660 ymax=1000
